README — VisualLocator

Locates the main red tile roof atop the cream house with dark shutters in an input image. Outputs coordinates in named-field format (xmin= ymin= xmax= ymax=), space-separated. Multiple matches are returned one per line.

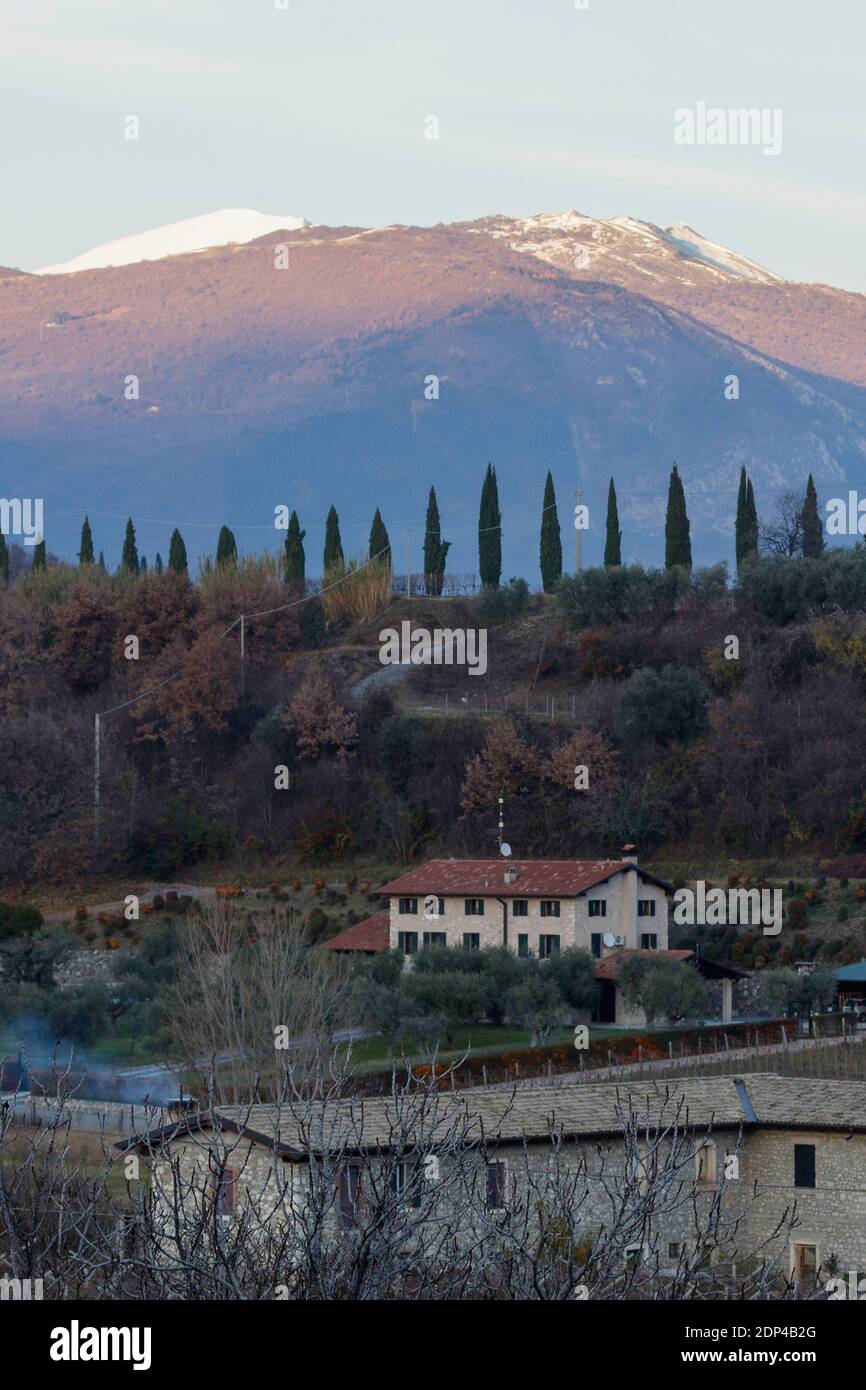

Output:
xmin=379 ymin=859 xmax=636 ymax=898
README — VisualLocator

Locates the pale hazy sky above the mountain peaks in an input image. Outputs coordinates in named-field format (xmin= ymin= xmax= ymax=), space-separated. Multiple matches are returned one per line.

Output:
xmin=6 ymin=0 xmax=866 ymax=291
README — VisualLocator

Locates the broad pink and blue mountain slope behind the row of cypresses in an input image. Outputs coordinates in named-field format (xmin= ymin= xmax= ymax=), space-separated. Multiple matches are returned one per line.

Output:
xmin=0 ymin=212 xmax=866 ymax=577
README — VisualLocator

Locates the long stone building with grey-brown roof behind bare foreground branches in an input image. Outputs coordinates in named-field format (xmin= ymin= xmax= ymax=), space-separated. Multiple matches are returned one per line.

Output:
xmin=117 ymin=1074 xmax=866 ymax=1283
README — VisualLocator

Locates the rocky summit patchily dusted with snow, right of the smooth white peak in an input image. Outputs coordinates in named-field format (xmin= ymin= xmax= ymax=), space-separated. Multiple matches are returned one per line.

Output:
xmin=464 ymin=209 xmax=784 ymax=284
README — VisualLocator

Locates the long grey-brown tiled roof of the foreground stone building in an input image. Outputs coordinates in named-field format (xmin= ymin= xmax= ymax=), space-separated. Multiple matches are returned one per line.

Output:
xmin=117 ymin=1073 xmax=866 ymax=1161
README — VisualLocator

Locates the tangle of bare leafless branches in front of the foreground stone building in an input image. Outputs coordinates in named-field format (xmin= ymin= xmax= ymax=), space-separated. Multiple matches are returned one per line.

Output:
xmin=0 ymin=1068 xmax=820 ymax=1301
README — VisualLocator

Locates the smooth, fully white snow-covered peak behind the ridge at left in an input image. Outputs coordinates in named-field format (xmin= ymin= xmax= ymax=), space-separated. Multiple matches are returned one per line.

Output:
xmin=36 ymin=207 xmax=311 ymax=275
